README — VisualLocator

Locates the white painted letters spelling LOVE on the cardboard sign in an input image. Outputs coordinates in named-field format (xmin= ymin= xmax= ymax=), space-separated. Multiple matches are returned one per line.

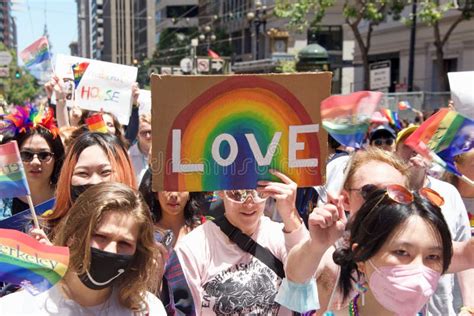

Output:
xmin=171 ymin=124 xmax=319 ymax=173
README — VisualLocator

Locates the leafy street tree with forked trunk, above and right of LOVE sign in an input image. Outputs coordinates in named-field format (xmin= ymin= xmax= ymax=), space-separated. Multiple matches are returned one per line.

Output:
xmin=274 ymin=0 xmax=407 ymax=90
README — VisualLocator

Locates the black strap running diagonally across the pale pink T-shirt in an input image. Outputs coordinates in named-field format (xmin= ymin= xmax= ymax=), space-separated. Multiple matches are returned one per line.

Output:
xmin=214 ymin=216 xmax=285 ymax=279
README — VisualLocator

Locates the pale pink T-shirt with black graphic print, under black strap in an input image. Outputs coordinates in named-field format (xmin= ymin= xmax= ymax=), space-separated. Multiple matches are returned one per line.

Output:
xmin=175 ymin=217 xmax=307 ymax=315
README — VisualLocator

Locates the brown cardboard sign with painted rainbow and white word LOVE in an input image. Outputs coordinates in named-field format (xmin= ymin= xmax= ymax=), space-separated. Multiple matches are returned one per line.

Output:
xmin=151 ymin=72 xmax=331 ymax=191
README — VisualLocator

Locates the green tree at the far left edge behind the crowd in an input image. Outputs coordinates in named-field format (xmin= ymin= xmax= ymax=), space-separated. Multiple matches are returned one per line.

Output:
xmin=0 ymin=43 xmax=40 ymax=105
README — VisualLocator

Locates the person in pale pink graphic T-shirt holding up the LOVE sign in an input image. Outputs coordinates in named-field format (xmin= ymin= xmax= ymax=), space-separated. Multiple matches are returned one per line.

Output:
xmin=175 ymin=171 xmax=307 ymax=315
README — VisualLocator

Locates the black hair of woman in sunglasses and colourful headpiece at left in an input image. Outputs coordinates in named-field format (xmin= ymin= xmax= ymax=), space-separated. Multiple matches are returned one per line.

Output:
xmin=2 ymin=125 xmax=64 ymax=186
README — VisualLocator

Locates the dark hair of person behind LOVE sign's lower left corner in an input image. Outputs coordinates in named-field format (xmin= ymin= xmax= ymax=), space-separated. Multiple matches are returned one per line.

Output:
xmin=138 ymin=168 xmax=201 ymax=228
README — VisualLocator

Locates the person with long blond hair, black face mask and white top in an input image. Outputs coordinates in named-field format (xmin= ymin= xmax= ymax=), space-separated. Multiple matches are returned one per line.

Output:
xmin=0 ymin=183 xmax=166 ymax=316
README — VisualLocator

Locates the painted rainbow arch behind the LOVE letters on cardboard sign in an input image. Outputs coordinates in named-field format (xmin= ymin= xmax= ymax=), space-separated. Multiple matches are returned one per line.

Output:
xmin=163 ymin=76 xmax=322 ymax=191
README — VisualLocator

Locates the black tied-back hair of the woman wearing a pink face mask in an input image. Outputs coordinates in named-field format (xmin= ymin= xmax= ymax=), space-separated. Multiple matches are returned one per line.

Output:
xmin=333 ymin=190 xmax=453 ymax=299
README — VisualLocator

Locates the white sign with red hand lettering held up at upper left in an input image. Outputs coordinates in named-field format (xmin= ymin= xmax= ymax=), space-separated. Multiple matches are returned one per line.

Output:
xmin=56 ymin=54 xmax=138 ymax=125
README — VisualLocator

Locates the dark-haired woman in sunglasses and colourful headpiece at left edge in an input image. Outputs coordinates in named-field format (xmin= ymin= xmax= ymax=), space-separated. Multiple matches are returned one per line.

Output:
xmin=0 ymin=104 xmax=64 ymax=220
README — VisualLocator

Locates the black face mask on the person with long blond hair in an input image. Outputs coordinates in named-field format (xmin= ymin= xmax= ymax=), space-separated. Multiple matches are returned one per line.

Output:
xmin=79 ymin=247 xmax=134 ymax=290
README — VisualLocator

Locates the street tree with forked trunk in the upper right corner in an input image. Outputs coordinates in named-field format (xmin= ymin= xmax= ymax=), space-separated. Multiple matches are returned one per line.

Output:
xmin=417 ymin=0 xmax=474 ymax=90
